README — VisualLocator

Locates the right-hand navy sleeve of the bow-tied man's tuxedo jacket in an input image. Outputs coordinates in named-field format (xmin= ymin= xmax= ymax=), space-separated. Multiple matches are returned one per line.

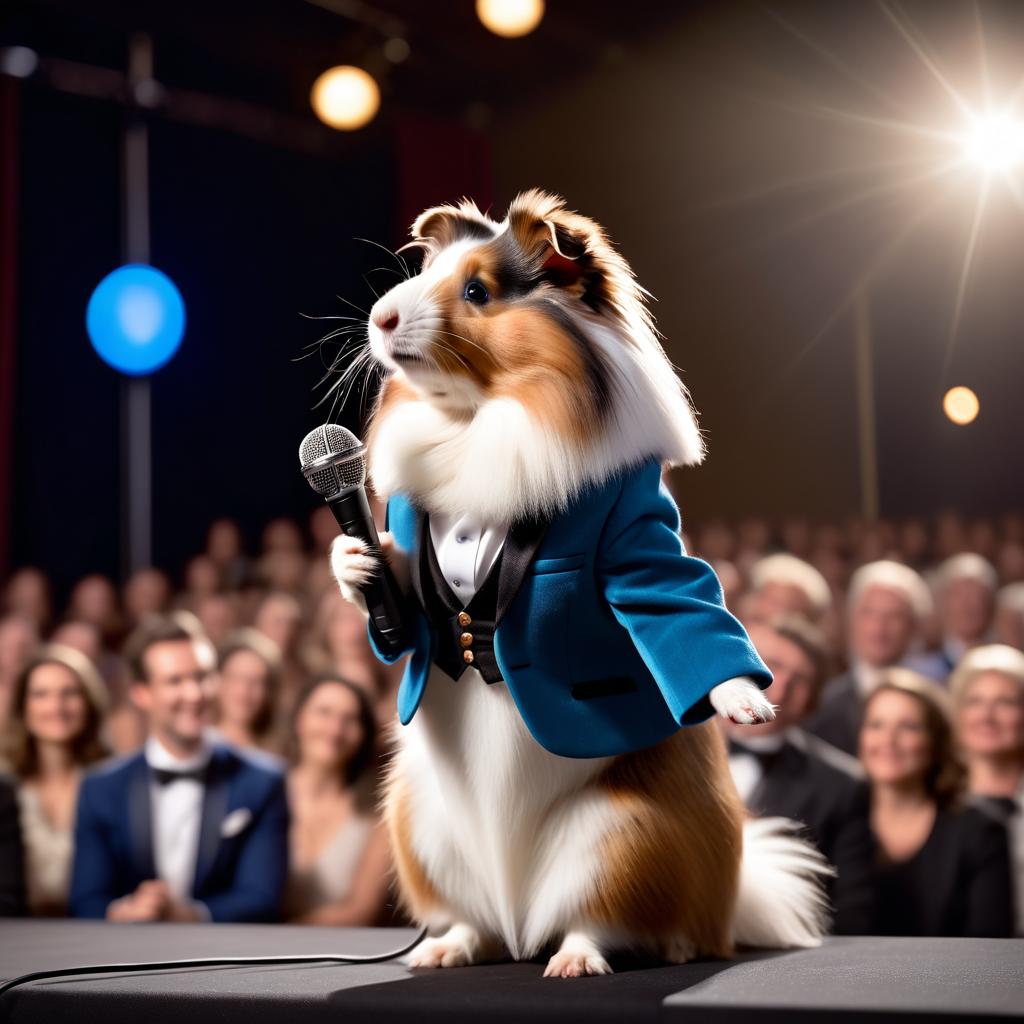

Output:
xmin=203 ymin=774 xmax=288 ymax=922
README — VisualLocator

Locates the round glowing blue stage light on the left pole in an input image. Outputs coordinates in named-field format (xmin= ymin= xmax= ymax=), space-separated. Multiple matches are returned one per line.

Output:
xmin=85 ymin=263 xmax=185 ymax=377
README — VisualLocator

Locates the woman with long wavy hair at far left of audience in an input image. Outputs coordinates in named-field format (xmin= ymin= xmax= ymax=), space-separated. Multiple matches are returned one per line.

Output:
xmin=4 ymin=644 xmax=106 ymax=916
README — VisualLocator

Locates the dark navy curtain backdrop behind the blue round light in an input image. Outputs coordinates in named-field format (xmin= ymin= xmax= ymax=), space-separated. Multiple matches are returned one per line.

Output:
xmin=11 ymin=88 xmax=396 ymax=596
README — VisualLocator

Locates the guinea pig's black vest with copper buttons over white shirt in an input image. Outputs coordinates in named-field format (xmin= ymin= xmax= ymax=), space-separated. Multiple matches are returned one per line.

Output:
xmin=420 ymin=517 xmax=505 ymax=683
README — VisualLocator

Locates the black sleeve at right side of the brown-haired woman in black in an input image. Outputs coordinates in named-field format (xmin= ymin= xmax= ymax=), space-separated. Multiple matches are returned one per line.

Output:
xmin=963 ymin=809 xmax=1014 ymax=938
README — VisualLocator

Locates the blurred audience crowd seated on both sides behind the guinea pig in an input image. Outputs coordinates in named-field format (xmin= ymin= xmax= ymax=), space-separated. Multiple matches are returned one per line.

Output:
xmin=0 ymin=507 xmax=1024 ymax=934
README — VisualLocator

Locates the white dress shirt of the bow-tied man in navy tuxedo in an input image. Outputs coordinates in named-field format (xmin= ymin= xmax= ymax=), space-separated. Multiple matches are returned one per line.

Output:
xmin=145 ymin=736 xmax=212 ymax=903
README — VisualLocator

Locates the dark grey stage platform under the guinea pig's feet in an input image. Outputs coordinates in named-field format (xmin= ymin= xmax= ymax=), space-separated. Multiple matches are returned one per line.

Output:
xmin=0 ymin=920 xmax=1024 ymax=1024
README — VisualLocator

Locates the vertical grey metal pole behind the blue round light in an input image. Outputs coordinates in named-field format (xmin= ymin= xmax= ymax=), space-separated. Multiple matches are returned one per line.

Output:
xmin=121 ymin=34 xmax=153 ymax=575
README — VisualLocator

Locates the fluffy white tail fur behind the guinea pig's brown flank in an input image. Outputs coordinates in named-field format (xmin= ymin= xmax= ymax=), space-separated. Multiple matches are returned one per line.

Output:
xmin=732 ymin=818 xmax=836 ymax=949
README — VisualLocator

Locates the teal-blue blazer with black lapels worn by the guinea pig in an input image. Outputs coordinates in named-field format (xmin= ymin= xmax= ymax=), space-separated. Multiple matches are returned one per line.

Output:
xmin=369 ymin=460 xmax=771 ymax=758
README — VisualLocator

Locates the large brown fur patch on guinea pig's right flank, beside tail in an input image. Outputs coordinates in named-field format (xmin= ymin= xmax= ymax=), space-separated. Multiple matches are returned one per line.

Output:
xmin=585 ymin=722 xmax=743 ymax=956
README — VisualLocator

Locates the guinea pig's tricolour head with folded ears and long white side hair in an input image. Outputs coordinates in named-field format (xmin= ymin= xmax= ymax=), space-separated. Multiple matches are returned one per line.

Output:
xmin=368 ymin=188 xmax=702 ymax=516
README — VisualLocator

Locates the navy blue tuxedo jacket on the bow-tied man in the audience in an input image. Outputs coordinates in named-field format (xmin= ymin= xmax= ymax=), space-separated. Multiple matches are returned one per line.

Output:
xmin=70 ymin=745 xmax=288 ymax=922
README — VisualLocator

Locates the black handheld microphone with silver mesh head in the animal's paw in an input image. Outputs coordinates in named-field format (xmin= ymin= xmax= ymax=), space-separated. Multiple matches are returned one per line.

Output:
xmin=299 ymin=423 xmax=404 ymax=654
